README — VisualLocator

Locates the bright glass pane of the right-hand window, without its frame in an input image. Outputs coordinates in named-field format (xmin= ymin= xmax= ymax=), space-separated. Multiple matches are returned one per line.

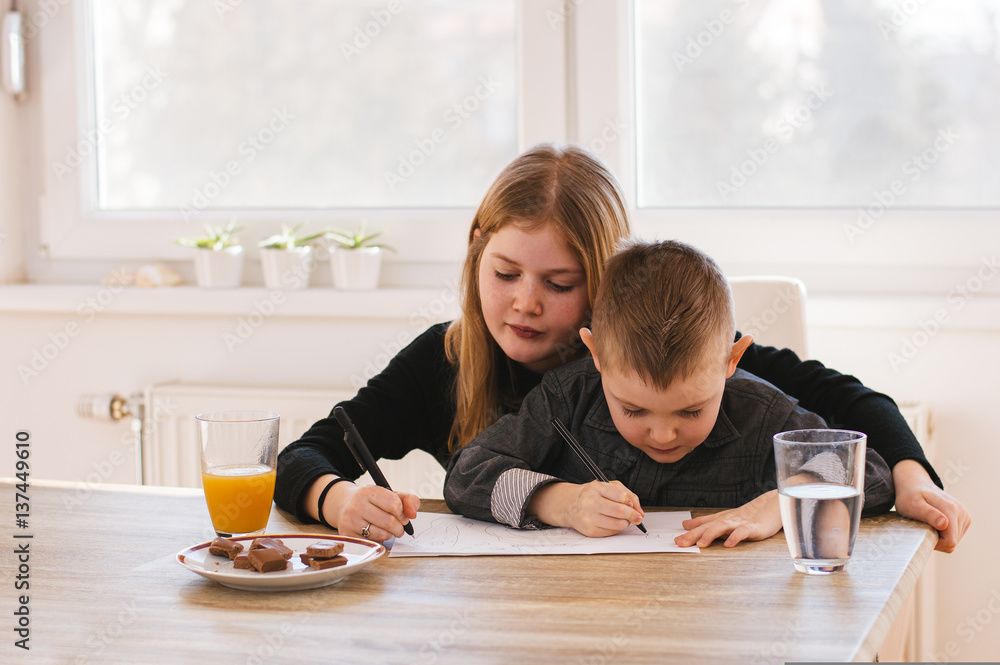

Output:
xmin=635 ymin=0 xmax=1000 ymax=208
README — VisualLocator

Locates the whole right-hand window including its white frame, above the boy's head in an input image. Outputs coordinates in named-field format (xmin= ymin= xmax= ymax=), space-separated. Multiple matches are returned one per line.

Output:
xmin=568 ymin=0 xmax=1000 ymax=297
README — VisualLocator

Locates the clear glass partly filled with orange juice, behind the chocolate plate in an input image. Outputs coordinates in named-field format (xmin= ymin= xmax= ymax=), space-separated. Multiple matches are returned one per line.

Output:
xmin=195 ymin=411 xmax=279 ymax=538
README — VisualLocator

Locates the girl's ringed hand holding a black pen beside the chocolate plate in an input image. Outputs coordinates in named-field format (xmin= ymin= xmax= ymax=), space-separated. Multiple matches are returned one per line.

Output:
xmin=323 ymin=474 xmax=420 ymax=542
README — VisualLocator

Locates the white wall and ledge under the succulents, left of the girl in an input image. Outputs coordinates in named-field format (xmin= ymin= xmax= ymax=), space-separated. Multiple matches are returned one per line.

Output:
xmin=0 ymin=286 xmax=456 ymax=483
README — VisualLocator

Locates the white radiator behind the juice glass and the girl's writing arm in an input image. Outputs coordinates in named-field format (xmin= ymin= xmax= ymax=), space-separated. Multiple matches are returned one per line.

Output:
xmin=140 ymin=382 xmax=444 ymax=499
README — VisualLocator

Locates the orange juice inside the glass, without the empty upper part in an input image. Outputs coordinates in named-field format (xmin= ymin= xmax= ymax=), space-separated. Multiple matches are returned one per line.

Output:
xmin=201 ymin=464 xmax=275 ymax=534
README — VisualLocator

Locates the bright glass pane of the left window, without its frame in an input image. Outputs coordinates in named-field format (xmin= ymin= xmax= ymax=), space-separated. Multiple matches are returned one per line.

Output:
xmin=90 ymin=0 xmax=517 ymax=210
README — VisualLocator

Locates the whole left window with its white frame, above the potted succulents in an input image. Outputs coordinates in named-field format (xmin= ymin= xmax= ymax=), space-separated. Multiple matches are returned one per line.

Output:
xmin=35 ymin=0 xmax=566 ymax=264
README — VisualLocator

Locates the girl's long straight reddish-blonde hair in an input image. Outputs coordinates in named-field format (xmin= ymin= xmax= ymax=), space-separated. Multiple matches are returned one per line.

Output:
xmin=445 ymin=144 xmax=629 ymax=452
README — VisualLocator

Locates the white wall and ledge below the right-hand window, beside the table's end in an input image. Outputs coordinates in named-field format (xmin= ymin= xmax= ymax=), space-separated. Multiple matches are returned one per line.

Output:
xmin=810 ymin=298 xmax=1000 ymax=662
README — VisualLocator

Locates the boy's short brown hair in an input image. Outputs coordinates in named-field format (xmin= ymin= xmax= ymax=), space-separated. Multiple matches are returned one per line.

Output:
xmin=591 ymin=240 xmax=736 ymax=390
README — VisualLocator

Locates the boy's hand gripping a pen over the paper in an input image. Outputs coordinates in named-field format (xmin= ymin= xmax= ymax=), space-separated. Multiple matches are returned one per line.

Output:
xmin=528 ymin=480 xmax=644 ymax=538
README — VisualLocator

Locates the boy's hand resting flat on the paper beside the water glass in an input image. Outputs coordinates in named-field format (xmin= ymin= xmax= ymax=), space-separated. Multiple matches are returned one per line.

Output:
xmin=674 ymin=490 xmax=781 ymax=547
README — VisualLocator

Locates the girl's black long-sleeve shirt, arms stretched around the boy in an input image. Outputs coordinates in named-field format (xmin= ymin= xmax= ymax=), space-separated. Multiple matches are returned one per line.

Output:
xmin=274 ymin=323 xmax=941 ymax=521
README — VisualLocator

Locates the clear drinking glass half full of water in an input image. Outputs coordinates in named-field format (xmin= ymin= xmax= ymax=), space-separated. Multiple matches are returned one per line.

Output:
xmin=774 ymin=429 xmax=868 ymax=575
